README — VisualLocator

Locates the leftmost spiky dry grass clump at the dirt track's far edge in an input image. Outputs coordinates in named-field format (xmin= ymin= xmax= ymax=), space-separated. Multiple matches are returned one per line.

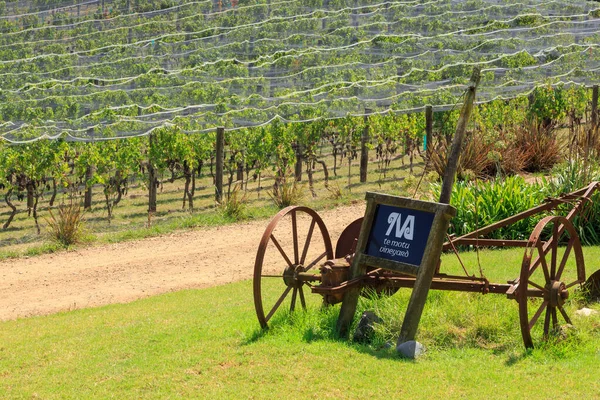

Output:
xmin=46 ymin=202 xmax=85 ymax=247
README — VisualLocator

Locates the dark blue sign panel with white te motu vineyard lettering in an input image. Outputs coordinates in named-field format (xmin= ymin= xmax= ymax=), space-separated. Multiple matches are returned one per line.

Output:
xmin=365 ymin=204 xmax=435 ymax=267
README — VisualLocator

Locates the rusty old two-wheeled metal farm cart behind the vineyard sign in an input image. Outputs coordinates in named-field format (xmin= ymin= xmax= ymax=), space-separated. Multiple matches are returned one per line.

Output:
xmin=253 ymin=182 xmax=600 ymax=347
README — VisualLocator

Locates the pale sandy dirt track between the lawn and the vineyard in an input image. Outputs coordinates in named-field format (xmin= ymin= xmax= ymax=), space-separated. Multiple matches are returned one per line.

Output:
xmin=0 ymin=202 xmax=364 ymax=320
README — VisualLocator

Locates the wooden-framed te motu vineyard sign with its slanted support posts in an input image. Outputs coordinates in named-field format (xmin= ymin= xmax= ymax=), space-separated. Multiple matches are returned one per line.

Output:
xmin=337 ymin=69 xmax=480 ymax=344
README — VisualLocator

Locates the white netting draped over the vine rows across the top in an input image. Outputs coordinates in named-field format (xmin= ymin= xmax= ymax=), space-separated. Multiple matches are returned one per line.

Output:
xmin=0 ymin=0 xmax=600 ymax=142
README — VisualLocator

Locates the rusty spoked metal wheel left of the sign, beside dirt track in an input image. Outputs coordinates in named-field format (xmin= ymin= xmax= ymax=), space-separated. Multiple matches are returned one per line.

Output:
xmin=253 ymin=206 xmax=333 ymax=329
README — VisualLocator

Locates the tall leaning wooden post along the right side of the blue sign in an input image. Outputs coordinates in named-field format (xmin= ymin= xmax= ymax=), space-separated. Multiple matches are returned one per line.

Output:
xmin=398 ymin=69 xmax=480 ymax=344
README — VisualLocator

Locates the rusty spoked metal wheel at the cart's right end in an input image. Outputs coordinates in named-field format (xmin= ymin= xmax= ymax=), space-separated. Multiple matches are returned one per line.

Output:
xmin=517 ymin=216 xmax=585 ymax=348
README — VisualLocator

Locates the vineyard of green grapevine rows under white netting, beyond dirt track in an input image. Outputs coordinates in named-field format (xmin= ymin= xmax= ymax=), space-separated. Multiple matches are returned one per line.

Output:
xmin=0 ymin=0 xmax=600 ymax=250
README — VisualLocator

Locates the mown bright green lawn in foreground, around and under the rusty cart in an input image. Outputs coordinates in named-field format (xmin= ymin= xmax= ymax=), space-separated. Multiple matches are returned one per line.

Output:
xmin=0 ymin=247 xmax=600 ymax=399
